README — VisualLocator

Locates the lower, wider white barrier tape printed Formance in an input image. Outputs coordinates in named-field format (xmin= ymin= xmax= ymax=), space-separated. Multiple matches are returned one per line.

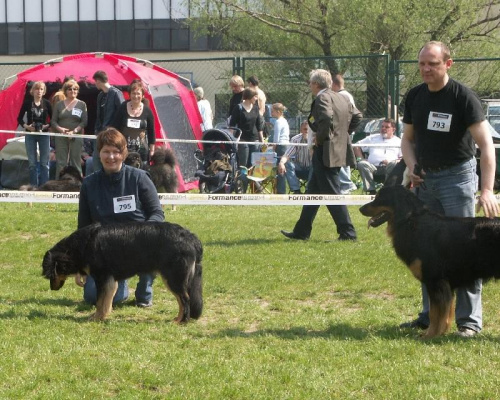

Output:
xmin=0 ymin=190 xmax=500 ymax=206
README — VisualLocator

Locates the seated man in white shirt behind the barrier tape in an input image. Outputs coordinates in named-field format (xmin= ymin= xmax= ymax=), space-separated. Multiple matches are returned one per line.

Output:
xmin=354 ymin=118 xmax=401 ymax=194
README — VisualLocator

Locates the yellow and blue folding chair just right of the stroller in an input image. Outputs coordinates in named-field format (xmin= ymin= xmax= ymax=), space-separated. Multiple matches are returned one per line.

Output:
xmin=247 ymin=152 xmax=277 ymax=194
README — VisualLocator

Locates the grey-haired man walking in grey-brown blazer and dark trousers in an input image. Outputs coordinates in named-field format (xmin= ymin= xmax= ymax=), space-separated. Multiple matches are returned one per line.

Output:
xmin=281 ymin=69 xmax=361 ymax=240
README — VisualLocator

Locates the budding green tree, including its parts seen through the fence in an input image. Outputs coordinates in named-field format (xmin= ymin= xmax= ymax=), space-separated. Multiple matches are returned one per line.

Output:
xmin=189 ymin=0 xmax=500 ymax=117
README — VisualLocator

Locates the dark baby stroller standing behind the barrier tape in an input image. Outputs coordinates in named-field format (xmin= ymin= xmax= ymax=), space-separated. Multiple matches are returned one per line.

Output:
xmin=194 ymin=128 xmax=242 ymax=193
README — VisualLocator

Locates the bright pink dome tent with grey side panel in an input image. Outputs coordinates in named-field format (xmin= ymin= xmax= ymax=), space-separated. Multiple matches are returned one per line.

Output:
xmin=0 ymin=53 xmax=202 ymax=192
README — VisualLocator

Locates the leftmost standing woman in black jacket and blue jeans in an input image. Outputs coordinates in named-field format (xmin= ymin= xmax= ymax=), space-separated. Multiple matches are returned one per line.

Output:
xmin=17 ymin=81 xmax=52 ymax=187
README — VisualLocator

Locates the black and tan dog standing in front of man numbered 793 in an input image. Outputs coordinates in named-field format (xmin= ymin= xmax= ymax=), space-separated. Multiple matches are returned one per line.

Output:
xmin=360 ymin=186 xmax=500 ymax=339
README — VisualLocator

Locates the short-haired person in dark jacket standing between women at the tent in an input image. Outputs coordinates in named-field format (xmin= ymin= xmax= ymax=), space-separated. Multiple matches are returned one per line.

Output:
xmin=93 ymin=70 xmax=125 ymax=171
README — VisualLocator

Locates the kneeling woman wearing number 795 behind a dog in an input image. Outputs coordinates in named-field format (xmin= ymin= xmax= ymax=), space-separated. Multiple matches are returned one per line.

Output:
xmin=75 ymin=128 xmax=165 ymax=307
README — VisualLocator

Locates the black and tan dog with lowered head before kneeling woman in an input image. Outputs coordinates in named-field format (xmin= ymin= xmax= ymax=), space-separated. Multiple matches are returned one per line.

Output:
xmin=42 ymin=222 xmax=203 ymax=323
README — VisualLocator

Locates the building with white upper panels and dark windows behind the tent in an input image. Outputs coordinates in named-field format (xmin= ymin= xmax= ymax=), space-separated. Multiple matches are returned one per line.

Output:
xmin=0 ymin=0 xmax=218 ymax=55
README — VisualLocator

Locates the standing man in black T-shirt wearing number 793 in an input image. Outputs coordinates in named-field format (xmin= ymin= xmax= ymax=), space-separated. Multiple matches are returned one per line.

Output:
xmin=400 ymin=41 xmax=498 ymax=337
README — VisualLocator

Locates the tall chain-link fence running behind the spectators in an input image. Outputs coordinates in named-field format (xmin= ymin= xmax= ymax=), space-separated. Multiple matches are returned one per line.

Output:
xmin=0 ymin=55 xmax=500 ymax=133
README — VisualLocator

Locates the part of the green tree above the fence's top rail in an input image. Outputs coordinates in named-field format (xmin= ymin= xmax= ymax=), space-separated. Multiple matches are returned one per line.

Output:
xmin=190 ymin=0 xmax=500 ymax=60
